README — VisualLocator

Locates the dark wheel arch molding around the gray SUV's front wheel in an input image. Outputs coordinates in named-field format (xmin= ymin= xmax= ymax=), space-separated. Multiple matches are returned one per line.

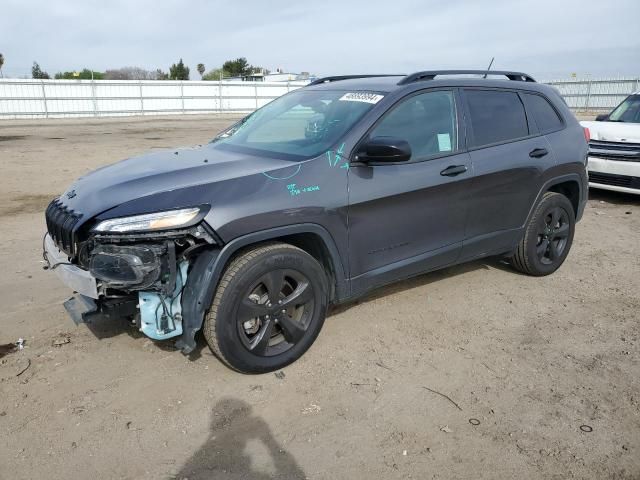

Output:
xmin=176 ymin=223 xmax=349 ymax=354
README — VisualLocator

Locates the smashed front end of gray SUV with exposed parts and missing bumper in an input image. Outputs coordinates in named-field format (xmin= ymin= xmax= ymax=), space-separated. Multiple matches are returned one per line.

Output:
xmin=44 ymin=201 xmax=220 ymax=353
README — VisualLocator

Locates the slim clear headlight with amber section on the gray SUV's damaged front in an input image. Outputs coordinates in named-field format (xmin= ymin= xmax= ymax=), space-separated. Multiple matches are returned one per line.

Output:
xmin=93 ymin=207 xmax=202 ymax=233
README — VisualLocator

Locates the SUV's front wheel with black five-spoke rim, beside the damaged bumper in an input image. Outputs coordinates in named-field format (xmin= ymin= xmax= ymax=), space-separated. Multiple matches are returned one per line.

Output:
xmin=203 ymin=243 xmax=328 ymax=373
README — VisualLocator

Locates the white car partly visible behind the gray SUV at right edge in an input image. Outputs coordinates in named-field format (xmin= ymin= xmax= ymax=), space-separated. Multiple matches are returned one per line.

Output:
xmin=580 ymin=92 xmax=640 ymax=195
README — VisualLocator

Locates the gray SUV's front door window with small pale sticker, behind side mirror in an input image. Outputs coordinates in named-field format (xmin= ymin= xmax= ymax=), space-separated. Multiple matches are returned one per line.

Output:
xmin=369 ymin=91 xmax=458 ymax=160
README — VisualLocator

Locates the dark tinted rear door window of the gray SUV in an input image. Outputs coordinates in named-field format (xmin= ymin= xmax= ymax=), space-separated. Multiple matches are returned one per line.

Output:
xmin=465 ymin=90 xmax=529 ymax=147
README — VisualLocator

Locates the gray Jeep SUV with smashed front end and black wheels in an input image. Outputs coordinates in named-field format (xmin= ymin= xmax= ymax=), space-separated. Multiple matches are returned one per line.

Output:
xmin=43 ymin=71 xmax=587 ymax=373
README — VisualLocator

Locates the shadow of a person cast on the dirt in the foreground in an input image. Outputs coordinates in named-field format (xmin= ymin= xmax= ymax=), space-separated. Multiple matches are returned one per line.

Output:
xmin=175 ymin=397 xmax=305 ymax=480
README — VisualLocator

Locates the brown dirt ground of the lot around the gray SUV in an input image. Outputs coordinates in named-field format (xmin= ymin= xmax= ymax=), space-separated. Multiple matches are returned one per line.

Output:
xmin=0 ymin=116 xmax=640 ymax=480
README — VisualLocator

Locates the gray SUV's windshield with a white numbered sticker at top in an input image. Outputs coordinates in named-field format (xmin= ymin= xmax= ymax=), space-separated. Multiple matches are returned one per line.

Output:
xmin=212 ymin=88 xmax=383 ymax=160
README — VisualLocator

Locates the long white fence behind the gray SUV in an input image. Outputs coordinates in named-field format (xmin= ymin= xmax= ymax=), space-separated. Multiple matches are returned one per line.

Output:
xmin=0 ymin=77 xmax=640 ymax=119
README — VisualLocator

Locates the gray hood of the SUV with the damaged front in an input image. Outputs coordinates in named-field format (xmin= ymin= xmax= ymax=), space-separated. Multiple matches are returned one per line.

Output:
xmin=60 ymin=144 xmax=292 ymax=221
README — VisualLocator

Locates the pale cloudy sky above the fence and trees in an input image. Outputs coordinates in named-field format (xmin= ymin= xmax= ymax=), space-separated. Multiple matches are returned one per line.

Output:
xmin=0 ymin=0 xmax=640 ymax=80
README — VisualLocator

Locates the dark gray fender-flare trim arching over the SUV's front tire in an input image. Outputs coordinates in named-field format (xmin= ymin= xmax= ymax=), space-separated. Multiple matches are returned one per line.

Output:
xmin=176 ymin=223 xmax=349 ymax=355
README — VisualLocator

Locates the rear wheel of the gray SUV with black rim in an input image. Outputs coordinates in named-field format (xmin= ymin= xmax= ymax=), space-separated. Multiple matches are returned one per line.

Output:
xmin=509 ymin=192 xmax=576 ymax=276
